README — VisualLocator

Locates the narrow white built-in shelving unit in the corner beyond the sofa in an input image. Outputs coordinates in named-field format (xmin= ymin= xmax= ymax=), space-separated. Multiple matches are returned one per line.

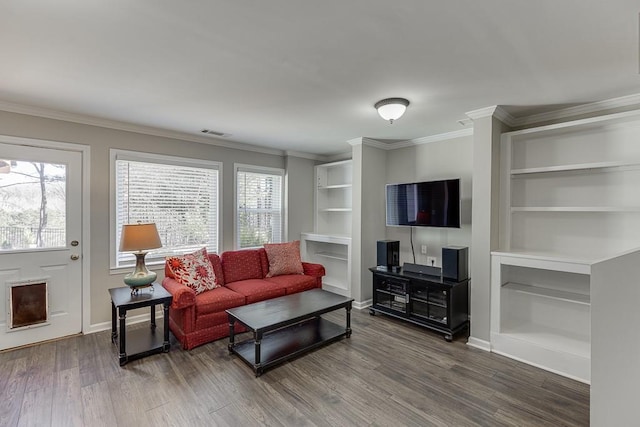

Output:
xmin=301 ymin=160 xmax=353 ymax=296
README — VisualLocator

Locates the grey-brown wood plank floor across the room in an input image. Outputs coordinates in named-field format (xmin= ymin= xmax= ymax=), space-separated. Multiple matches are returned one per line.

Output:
xmin=0 ymin=310 xmax=589 ymax=426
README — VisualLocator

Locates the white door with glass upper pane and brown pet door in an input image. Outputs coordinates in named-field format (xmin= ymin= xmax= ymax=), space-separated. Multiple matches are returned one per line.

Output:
xmin=0 ymin=139 xmax=83 ymax=350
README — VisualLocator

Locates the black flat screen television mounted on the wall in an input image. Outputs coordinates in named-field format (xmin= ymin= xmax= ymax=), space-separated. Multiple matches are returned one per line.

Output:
xmin=386 ymin=178 xmax=460 ymax=228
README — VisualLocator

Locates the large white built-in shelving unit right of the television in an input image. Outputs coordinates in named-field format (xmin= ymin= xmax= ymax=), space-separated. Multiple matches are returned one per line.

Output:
xmin=491 ymin=111 xmax=640 ymax=382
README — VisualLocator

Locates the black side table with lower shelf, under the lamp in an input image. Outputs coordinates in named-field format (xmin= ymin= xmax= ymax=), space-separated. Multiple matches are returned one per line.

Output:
xmin=109 ymin=283 xmax=173 ymax=366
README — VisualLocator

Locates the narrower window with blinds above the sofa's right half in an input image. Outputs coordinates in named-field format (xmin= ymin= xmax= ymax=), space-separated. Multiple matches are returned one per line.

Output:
xmin=235 ymin=165 xmax=284 ymax=249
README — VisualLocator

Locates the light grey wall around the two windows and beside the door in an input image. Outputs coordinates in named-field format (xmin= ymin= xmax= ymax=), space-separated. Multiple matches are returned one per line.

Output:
xmin=0 ymin=111 xmax=313 ymax=325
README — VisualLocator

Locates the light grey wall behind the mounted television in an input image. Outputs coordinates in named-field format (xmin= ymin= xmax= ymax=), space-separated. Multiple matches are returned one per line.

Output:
xmin=381 ymin=136 xmax=473 ymax=270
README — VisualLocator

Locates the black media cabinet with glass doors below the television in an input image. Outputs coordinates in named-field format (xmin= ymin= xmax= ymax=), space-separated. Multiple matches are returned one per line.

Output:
xmin=369 ymin=267 xmax=469 ymax=341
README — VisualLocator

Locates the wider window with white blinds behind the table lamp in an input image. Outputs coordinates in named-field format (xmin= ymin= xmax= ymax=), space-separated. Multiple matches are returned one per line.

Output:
xmin=111 ymin=150 xmax=222 ymax=268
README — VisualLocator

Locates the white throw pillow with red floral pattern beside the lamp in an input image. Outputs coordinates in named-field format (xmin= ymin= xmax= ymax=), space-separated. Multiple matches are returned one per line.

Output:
xmin=167 ymin=248 xmax=218 ymax=295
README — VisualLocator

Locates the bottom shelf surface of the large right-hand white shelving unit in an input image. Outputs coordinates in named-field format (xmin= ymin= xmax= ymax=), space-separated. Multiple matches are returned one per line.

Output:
xmin=500 ymin=323 xmax=591 ymax=359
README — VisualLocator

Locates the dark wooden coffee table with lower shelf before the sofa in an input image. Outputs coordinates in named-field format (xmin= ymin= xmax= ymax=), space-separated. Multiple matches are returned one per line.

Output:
xmin=227 ymin=289 xmax=353 ymax=377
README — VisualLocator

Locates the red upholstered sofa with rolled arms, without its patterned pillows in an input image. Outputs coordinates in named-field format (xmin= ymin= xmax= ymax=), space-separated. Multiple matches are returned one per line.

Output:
xmin=162 ymin=248 xmax=325 ymax=350
